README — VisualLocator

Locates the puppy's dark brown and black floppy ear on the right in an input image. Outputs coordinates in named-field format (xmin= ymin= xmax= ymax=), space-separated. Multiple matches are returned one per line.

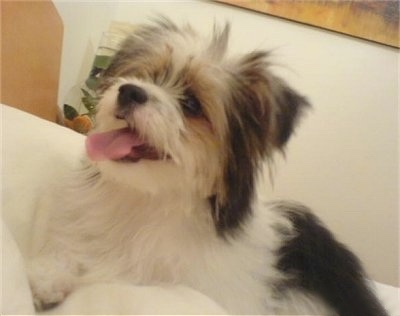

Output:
xmin=210 ymin=52 xmax=309 ymax=233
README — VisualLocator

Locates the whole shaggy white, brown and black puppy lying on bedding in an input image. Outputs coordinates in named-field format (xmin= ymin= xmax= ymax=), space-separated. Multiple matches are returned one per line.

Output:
xmin=30 ymin=19 xmax=386 ymax=316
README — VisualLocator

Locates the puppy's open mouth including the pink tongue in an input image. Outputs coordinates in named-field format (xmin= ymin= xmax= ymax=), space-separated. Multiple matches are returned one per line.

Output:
xmin=86 ymin=128 xmax=162 ymax=162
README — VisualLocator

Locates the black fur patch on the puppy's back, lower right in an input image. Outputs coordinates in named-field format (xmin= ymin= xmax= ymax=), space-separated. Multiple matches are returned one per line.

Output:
xmin=277 ymin=204 xmax=388 ymax=316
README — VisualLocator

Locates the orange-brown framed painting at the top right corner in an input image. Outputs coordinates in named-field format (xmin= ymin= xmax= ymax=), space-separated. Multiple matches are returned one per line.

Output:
xmin=217 ymin=0 xmax=400 ymax=48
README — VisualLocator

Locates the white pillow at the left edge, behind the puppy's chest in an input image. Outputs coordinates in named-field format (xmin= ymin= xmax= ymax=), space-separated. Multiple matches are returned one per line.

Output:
xmin=1 ymin=105 xmax=84 ymax=256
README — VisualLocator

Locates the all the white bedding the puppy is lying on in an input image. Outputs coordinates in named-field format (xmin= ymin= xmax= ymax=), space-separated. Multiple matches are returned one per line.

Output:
xmin=1 ymin=106 xmax=400 ymax=316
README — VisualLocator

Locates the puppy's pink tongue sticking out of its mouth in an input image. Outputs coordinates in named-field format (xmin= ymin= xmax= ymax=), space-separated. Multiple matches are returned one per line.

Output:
xmin=86 ymin=128 xmax=143 ymax=161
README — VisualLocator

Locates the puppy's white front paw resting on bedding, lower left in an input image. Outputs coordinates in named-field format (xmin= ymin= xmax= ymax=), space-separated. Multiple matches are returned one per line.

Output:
xmin=28 ymin=257 xmax=76 ymax=310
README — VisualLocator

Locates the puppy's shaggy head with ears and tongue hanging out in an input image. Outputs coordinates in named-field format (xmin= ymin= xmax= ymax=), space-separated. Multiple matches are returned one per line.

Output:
xmin=87 ymin=19 xmax=308 ymax=232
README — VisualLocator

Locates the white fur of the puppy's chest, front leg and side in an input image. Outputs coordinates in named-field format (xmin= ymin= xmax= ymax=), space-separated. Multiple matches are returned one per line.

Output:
xmin=30 ymin=167 xmax=332 ymax=314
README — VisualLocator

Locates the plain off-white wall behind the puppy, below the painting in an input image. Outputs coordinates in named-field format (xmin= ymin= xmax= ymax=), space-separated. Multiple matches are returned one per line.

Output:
xmin=57 ymin=1 xmax=399 ymax=284
